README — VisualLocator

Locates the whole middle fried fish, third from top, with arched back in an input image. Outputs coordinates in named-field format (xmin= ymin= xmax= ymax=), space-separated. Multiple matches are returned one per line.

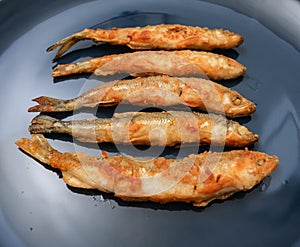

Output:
xmin=29 ymin=76 xmax=256 ymax=118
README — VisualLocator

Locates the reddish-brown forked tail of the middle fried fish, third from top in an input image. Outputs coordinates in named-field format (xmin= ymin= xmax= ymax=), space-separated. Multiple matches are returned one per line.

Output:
xmin=28 ymin=96 xmax=74 ymax=112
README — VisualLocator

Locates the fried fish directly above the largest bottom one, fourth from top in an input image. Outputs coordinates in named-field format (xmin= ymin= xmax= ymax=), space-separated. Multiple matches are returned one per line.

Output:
xmin=29 ymin=111 xmax=259 ymax=147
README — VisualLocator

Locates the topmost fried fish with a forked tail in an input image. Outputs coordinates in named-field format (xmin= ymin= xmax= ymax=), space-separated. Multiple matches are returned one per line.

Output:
xmin=47 ymin=24 xmax=244 ymax=60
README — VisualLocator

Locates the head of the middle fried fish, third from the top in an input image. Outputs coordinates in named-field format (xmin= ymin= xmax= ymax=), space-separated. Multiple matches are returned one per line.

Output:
xmin=223 ymin=92 xmax=256 ymax=117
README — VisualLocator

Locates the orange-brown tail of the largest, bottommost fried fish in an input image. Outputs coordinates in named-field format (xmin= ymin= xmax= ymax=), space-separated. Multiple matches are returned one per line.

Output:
xmin=16 ymin=134 xmax=53 ymax=165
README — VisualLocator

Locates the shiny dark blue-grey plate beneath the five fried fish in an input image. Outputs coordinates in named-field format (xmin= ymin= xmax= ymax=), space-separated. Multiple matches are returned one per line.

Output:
xmin=0 ymin=0 xmax=300 ymax=246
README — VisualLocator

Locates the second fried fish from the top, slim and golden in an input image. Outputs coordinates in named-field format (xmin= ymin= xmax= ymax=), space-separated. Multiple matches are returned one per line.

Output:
xmin=52 ymin=50 xmax=246 ymax=80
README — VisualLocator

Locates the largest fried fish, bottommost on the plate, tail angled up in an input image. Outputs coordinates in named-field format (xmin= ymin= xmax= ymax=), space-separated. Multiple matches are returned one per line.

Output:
xmin=16 ymin=135 xmax=279 ymax=206
